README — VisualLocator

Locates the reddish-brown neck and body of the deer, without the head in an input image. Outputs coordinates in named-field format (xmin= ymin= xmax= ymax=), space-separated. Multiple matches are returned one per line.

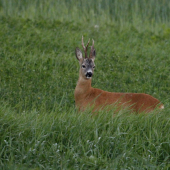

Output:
xmin=74 ymin=74 xmax=163 ymax=113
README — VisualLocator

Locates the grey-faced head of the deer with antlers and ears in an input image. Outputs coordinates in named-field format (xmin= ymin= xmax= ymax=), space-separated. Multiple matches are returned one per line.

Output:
xmin=75 ymin=36 xmax=96 ymax=79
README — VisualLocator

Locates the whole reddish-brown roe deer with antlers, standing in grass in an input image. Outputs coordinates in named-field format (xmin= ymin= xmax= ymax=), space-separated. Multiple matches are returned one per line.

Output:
xmin=74 ymin=36 xmax=164 ymax=113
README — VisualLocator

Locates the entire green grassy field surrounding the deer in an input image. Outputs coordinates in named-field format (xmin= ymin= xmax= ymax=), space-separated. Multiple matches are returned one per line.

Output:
xmin=0 ymin=0 xmax=170 ymax=170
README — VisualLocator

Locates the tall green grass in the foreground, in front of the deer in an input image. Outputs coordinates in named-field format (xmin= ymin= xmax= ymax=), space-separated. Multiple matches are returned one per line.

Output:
xmin=0 ymin=103 xmax=170 ymax=169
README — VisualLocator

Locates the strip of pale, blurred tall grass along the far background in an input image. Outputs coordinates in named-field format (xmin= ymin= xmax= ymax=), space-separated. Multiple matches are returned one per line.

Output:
xmin=0 ymin=0 xmax=170 ymax=24
